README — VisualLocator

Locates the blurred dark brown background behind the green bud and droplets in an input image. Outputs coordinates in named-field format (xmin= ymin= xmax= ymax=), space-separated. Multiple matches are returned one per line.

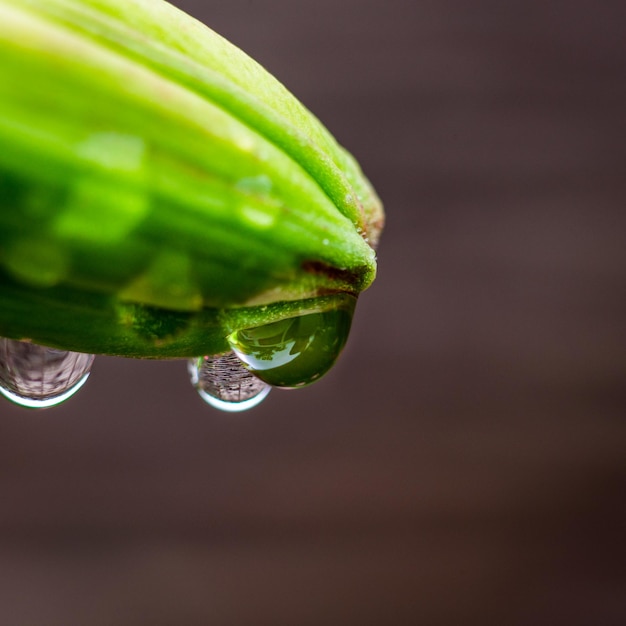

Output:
xmin=0 ymin=0 xmax=626 ymax=626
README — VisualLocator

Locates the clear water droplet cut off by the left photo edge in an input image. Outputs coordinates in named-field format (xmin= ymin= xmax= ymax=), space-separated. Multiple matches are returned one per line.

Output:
xmin=0 ymin=338 xmax=94 ymax=409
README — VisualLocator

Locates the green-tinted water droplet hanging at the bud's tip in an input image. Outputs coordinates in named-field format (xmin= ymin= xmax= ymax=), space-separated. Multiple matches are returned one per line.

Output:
xmin=228 ymin=298 xmax=356 ymax=388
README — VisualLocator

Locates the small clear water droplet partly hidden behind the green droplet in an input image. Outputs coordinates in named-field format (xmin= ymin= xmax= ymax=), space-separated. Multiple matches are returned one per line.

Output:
xmin=188 ymin=352 xmax=271 ymax=412
